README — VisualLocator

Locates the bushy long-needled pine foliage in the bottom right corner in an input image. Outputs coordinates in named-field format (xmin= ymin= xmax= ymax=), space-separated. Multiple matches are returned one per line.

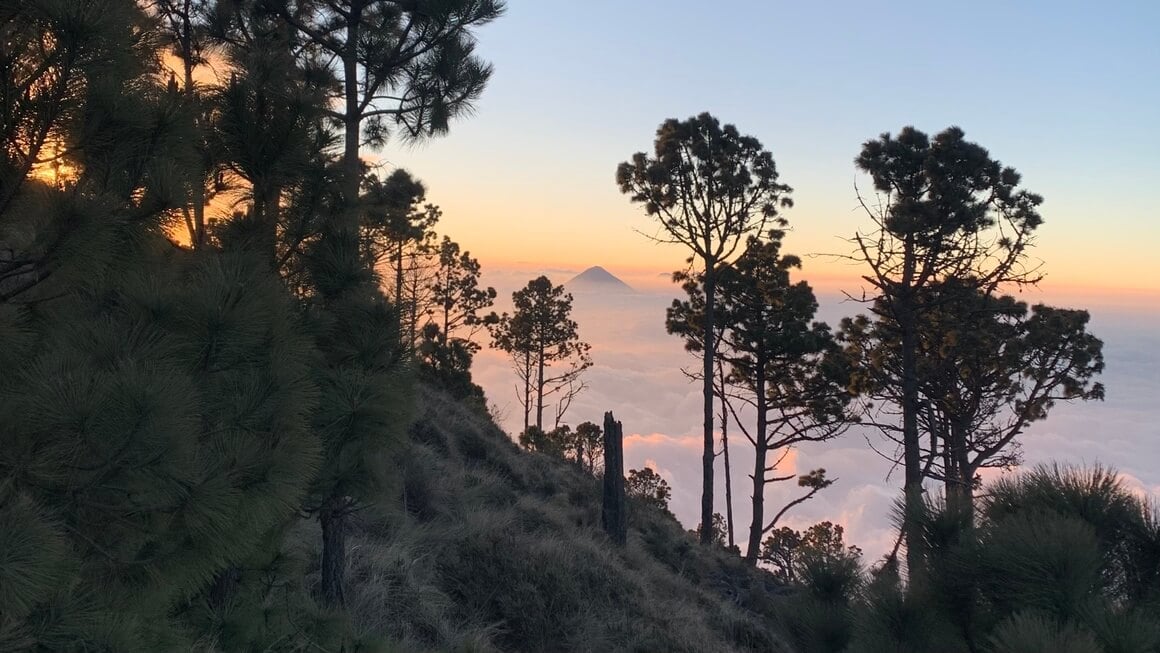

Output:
xmin=778 ymin=467 xmax=1160 ymax=653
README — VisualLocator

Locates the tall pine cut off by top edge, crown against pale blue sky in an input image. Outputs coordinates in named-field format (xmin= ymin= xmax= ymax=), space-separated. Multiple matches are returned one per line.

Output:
xmin=271 ymin=0 xmax=503 ymax=267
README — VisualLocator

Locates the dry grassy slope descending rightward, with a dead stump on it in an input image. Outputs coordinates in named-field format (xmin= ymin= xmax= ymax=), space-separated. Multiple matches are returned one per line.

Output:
xmin=331 ymin=389 xmax=788 ymax=653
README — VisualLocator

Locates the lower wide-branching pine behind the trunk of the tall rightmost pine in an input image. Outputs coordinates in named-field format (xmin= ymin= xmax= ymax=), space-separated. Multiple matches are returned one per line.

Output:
xmin=842 ymin=280 xmax=1103 ymax=511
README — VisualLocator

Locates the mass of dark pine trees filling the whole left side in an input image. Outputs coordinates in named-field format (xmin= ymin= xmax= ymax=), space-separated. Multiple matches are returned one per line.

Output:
xmin=0 ymin=0 xmax=502 ymax=651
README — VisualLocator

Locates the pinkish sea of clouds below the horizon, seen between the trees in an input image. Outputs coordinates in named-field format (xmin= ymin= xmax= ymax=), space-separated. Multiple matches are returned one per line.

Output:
xmin=474 ymin=270 xmax=1160 ymax=561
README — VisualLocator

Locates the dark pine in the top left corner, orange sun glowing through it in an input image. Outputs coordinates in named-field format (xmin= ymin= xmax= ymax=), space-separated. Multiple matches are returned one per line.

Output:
xmin=0 ymin=0 xmax=195 ymax=302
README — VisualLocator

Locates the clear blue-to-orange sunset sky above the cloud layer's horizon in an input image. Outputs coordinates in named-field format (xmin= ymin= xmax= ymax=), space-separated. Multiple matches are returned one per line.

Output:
xmin=392 ymin=0 xmax=1160 ymax=304
